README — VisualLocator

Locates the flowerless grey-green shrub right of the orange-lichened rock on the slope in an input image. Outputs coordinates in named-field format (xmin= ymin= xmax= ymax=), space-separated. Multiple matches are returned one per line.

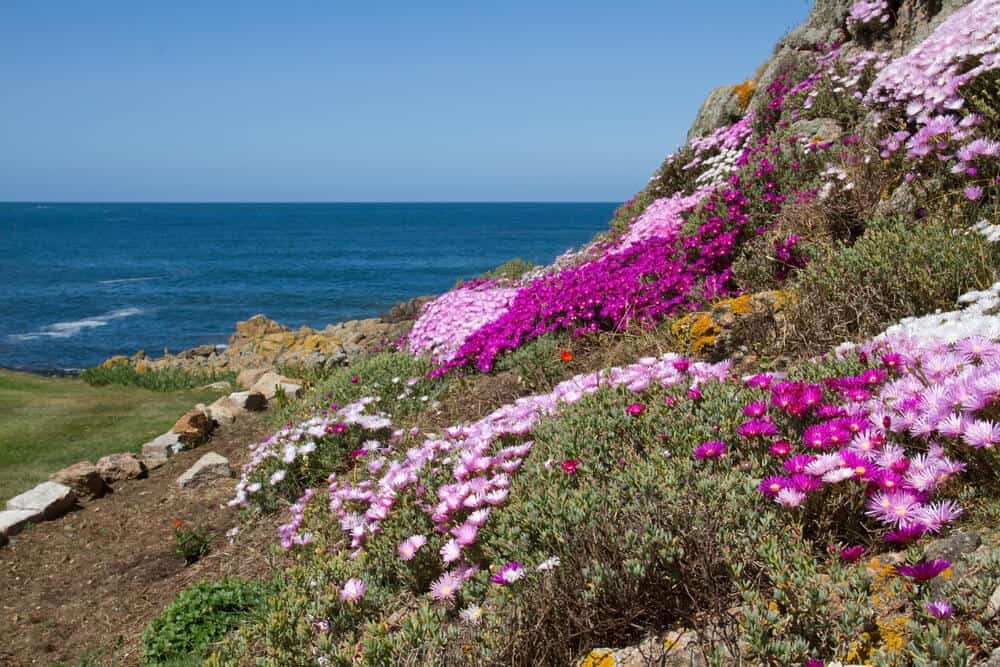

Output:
xmin=788 ymin=220 xmax=1000 ymax=354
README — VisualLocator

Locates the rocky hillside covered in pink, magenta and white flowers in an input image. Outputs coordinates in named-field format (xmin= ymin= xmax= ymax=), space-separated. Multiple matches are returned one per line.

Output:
xmin=1 ymin=0 xmax=1000 ymax=667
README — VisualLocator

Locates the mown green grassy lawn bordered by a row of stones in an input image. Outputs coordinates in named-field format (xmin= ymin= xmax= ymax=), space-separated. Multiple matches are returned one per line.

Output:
xmin=0 ymin=370 xmax=218 ymax=500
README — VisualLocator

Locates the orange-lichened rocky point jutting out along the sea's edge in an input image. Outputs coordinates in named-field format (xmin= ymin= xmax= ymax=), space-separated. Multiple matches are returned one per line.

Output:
xmin=101 ymin=296 xmax=434 ymax=372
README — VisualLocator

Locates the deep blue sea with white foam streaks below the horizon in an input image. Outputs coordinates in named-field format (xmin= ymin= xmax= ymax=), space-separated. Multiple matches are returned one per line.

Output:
xmin=0 ymin=203 xmax=615 ymax=370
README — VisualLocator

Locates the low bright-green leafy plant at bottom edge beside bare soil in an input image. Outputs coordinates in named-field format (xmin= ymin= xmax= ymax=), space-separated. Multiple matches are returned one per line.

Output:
xmin=142 ymin=578 xmax=264 ymax=665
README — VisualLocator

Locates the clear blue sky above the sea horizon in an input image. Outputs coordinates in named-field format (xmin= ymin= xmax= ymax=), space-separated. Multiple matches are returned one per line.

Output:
xmin=0 ymin=0 xmax=810 ymax=201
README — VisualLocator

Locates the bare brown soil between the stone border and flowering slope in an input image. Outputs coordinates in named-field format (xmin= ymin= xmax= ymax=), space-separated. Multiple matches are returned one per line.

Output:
xmin=0 ymin=415 xmax=283 ymax=667
